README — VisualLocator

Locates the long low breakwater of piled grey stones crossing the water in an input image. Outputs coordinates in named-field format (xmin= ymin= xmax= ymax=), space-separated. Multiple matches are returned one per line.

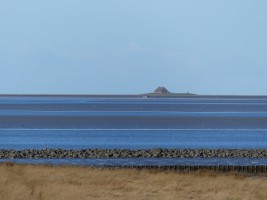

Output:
xmin=0 ymin=149 xmax=267 ymax=159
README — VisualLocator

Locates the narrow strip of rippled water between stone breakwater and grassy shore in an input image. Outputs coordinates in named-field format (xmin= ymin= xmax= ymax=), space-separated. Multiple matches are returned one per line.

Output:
xmin=0 ymin=158 xmax=267 ymax=167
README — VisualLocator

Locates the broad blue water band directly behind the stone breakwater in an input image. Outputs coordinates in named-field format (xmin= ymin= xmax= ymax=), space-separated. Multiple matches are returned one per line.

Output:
xmin=0 ymin=129 xmax=267 ymax=149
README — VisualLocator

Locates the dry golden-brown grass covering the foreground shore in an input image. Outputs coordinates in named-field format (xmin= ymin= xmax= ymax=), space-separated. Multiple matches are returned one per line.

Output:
xmin=0 ymin=163 xmax=267 ymax=200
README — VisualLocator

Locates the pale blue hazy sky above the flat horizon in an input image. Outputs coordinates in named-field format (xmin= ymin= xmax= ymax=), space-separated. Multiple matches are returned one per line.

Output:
xmin=0 ymin=0 xmax=267 ymax=95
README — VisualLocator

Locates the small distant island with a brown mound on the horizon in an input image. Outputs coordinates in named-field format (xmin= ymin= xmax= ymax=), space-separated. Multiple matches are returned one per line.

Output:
xmin=143 ymin=86 xmax=196 ymax=98
